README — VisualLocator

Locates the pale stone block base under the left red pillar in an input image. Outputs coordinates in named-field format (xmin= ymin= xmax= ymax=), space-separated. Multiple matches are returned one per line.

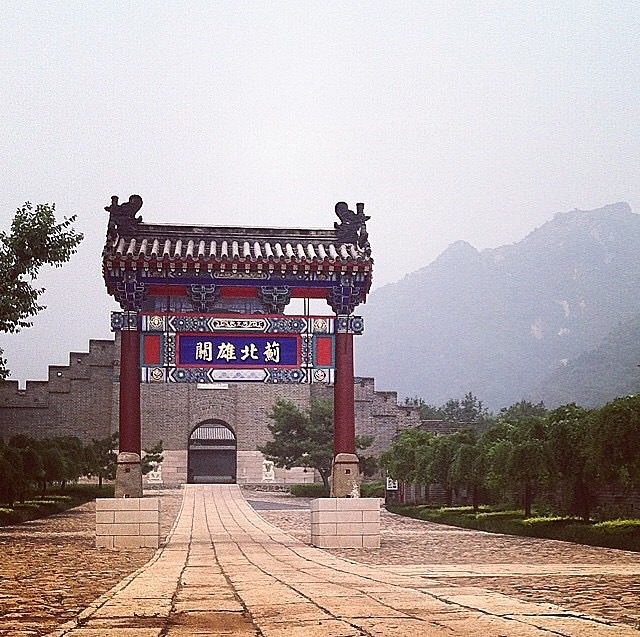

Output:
xmin=96 ymin=498 xmax=160 ymax=549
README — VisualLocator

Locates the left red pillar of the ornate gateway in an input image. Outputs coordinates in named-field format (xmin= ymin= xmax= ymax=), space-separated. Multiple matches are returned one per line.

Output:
xmin=119 ymin=312 xmax=141 ymax=455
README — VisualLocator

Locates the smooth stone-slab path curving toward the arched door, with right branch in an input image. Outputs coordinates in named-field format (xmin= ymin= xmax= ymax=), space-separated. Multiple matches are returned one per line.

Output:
xmin=45 ymin=485 xmax=640 ymax=637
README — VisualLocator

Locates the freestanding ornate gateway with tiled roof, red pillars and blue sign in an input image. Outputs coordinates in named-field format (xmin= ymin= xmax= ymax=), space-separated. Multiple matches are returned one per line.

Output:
xmin=102 ymin=195 xmax=373 ymax=497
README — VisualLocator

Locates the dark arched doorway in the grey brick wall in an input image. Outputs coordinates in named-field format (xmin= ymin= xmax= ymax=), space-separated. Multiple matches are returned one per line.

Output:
xmin=187 ymin=420 xmax=238 ymax=484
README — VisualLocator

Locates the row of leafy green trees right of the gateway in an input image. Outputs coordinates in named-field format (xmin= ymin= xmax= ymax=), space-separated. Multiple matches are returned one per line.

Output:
xmin=380 ymin=396 xmax=640 ymax=520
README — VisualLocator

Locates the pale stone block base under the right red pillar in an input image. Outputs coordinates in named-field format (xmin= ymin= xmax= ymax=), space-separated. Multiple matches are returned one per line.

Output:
xmin=311 ymin=498 xmax=380 ymax=549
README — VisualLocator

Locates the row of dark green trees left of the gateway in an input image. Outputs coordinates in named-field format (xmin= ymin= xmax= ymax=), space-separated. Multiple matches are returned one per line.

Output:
xmin=0 ymin=433 xmax=163 ymax=506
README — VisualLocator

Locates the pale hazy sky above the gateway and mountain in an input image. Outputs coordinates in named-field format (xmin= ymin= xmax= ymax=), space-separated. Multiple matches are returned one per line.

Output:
xmin=0 ymin=0 xmax=640 ymax=379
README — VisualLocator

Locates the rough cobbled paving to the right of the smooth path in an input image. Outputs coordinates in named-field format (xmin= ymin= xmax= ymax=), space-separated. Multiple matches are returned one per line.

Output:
xmin=254 ymin=493 xmax=640 ymax=635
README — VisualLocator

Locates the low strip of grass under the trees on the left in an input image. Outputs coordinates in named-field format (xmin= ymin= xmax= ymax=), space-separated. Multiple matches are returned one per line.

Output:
xmin=0 ymin=484 xmax=113 ymax=526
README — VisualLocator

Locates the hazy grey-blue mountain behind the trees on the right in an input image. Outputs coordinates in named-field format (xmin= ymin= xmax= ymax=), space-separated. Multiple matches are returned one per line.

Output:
xmin=356 ymin=203 xmax=640 ymax=409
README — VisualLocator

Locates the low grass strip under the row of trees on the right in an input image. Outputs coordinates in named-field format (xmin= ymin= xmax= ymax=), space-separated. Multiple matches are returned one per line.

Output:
xmin=387 ymin=505 xmax=640 ymax=551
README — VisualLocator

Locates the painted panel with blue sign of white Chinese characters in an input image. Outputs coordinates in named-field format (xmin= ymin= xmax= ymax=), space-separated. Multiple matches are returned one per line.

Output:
xmin=132 ymin=313 xmax=363 ymax=383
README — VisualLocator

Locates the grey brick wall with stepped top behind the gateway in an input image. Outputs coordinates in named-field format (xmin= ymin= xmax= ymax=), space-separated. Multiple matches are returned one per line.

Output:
xmin=0 ymin=340 xmax=420 ymax=484
